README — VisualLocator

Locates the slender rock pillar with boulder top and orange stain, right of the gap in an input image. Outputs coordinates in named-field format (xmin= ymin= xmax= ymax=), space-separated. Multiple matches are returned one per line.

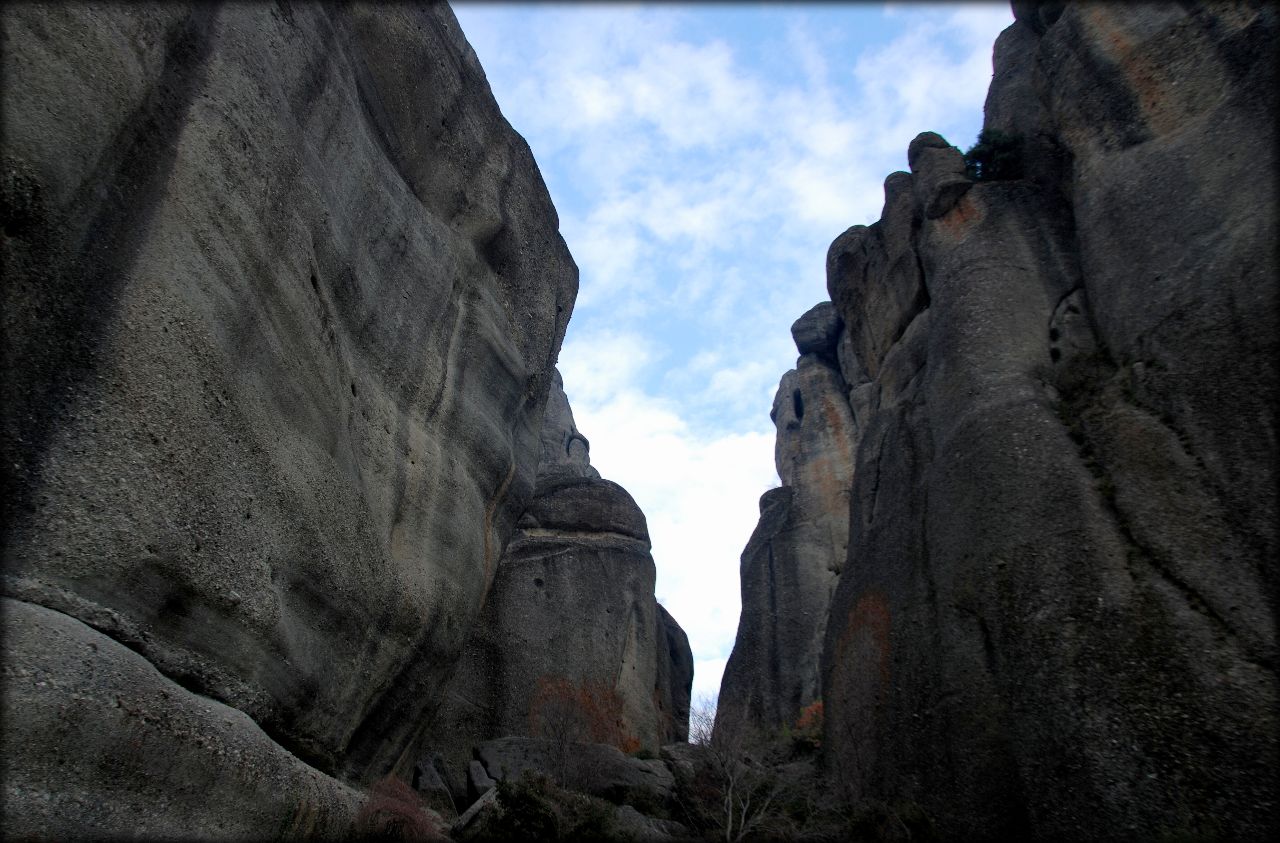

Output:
xmin=716 ymin=302 xmax=856 ymax=729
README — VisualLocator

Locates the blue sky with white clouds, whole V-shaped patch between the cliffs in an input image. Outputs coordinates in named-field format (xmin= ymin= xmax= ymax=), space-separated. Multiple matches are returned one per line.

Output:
xmin=453 ymin=3 xmax=1012 ymax=698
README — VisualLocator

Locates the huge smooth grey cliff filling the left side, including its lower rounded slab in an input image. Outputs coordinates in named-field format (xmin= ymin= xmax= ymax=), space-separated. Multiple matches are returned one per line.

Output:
xmin=0 ymin=3 xmax=576 ymax=835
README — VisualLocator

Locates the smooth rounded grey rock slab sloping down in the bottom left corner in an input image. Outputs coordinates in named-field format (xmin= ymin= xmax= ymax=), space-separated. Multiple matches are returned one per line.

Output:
xmin=3 ymin=597 xmax=365 ymax=840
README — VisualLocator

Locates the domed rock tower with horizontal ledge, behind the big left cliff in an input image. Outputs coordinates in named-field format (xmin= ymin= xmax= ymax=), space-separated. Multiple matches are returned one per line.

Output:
xmin=428 ymin=372 xmax=692 ymax=793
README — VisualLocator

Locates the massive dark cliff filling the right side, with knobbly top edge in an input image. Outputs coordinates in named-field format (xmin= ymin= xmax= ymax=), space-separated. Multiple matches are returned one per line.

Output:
xmin=823 ymin=4 xmax=1280 ymax=839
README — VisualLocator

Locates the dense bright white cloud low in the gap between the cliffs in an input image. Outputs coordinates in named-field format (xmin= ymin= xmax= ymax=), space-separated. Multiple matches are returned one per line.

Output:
xmin=561 ymin=335 xmax=777 ymax=701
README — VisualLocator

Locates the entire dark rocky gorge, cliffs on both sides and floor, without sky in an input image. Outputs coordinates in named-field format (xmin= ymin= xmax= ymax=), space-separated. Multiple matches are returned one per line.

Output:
xmin=0 ymin=0 xmax=1280 ymax=840
